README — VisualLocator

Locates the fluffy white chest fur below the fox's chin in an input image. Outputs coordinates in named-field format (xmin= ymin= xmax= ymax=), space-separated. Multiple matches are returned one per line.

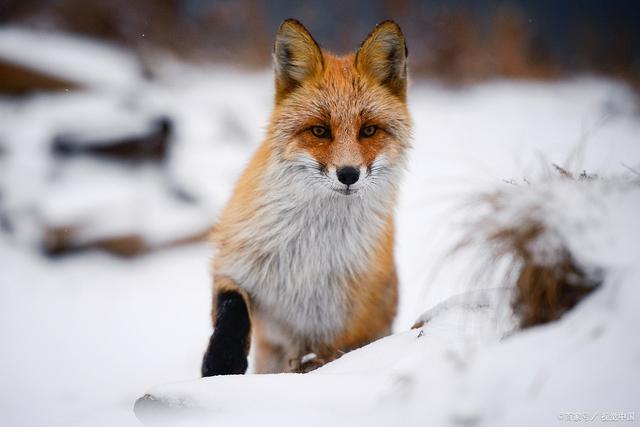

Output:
xmin=219 ymin=160 xmax=392 ymax=342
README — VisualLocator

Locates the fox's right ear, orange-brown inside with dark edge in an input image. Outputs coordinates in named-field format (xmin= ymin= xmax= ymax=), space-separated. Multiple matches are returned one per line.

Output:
xmin=356 ymin=21 xmax=407 ymax=98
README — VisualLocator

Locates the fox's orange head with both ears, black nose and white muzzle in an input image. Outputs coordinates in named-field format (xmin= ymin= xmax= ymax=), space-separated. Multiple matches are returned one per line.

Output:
xmin=269 ymin=19 xmax=410 ymax=197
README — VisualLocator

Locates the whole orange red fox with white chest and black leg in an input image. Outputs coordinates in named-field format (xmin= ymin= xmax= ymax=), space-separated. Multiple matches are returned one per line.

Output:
xmin=201 ymin=19 xmax=411 ymax=377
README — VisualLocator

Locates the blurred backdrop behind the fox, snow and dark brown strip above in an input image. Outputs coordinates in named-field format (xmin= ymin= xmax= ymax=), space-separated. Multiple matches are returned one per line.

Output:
xmin=0 ymin=0 xmax=640 ymax=426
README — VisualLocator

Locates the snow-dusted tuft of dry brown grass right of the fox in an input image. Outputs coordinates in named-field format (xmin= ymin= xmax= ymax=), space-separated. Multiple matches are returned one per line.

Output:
xmin=456 ymin=165 xmax=602 ymax=328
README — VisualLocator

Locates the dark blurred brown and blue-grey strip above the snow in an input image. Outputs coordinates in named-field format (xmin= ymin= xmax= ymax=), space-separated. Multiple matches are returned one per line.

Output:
xmin=0 ymin=0 xmax=640 ymax=84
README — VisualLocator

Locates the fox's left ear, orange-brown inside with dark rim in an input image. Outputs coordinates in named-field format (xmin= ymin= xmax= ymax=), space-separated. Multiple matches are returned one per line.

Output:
xmin=273 ymin=19 xmax=323 ymax=99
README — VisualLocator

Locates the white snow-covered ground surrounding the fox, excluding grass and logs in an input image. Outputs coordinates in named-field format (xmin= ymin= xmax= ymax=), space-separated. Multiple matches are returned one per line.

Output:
xmin=0 ymin=29 xmax=640 ymax=426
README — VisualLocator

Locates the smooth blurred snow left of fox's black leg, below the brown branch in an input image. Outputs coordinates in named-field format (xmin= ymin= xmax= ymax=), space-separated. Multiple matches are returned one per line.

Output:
xmin=0 ymin=239 xmax=210 ymax=426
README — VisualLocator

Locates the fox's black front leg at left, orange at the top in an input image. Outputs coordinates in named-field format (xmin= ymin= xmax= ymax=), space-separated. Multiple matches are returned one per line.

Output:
xmin=202 ymin=276 xmax=251 ymax=377
